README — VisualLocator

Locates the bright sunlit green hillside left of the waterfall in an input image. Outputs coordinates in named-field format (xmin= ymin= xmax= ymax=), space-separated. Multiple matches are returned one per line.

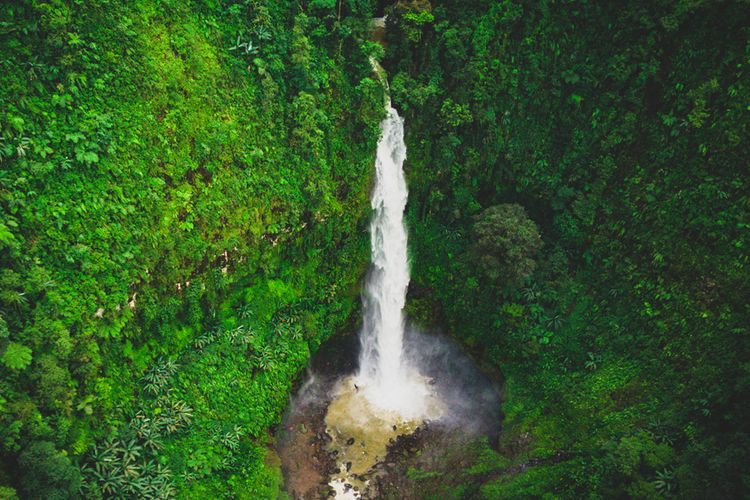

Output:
xmin=0 ymin=0 xmax=382 ymax=498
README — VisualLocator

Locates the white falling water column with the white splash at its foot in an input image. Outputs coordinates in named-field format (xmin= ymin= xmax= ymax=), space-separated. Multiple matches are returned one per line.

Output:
xmin=356 ymin=103 xmax=435 ymax=419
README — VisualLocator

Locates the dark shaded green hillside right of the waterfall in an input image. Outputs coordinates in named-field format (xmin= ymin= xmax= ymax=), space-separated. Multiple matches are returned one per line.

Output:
xmin=385 ymin=0 xmax=750 ymax=498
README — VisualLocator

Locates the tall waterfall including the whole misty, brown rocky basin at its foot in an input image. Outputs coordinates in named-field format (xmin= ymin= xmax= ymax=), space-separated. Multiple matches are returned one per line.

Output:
xmin=278 ymin=103 xmax=500 ymax=499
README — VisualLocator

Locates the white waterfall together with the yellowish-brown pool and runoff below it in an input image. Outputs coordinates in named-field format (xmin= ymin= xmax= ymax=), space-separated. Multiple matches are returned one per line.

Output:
xmin=325 ymin=99 xmax=443 ymax=499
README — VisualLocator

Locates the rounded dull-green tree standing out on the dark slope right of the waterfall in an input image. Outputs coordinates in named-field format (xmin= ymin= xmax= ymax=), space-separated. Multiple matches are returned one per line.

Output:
xmin=473 ymin=203 xmax=542 ymax=286
